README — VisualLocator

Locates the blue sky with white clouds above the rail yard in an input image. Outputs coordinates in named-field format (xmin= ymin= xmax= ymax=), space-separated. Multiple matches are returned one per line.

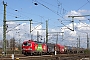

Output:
xmin=0 ymin=0 xmax=90 ymax=48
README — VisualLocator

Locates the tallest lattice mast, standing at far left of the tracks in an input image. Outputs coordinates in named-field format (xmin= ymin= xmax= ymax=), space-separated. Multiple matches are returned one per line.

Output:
xmin=3 ymin=1 xmax=7 ymax=56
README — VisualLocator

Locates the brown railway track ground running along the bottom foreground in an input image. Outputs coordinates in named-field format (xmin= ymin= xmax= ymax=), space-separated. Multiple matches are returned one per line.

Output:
xmin=0 ymin=54 xmax=90 ymax=60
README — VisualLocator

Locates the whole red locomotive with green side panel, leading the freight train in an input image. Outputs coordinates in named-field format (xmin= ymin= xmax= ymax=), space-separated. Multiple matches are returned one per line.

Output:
xmin=22 ymin=40 xmax=47 ymax=55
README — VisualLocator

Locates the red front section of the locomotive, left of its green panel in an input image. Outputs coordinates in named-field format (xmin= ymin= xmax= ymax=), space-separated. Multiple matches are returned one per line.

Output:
xmin=22 ymin=40 xmax=36 ymax=55
